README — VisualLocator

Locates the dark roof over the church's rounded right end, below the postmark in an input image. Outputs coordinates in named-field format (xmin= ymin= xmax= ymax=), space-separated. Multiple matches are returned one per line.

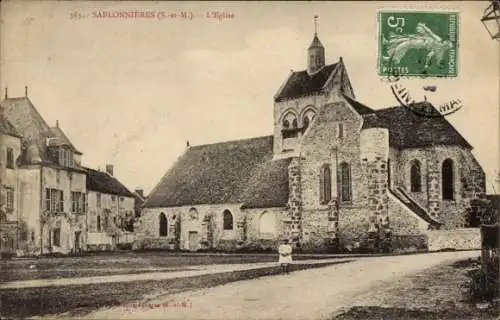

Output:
xmin=376 ymin=103 xmax=472 ymax=149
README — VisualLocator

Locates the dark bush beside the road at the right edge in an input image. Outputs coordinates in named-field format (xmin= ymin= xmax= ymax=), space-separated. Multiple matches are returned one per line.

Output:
xmin=468 ymin=252 xmax=500 ymax=302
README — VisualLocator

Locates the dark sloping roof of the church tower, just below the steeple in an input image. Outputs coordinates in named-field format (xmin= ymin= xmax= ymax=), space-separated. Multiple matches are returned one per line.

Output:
xmin=275 ymin=63 xmax=338 ymax=102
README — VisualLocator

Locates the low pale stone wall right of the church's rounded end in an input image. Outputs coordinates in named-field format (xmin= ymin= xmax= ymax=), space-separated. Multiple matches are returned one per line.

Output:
xmin=427 ymin=228 xmax=481 ymax=251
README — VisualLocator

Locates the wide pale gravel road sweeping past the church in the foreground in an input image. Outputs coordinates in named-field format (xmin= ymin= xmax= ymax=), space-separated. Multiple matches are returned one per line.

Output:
xmin=86 ymin=251 xmax=480 ymax=319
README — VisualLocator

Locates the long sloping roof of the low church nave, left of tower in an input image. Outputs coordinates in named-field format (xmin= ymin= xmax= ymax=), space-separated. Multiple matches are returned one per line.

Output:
xmin=143 ymin=136 xmax=290 ymax=208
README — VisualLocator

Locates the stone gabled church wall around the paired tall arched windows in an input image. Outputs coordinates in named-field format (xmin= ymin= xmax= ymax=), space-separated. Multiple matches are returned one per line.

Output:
xmin=300 ymin=100 xmax=367 ymax=250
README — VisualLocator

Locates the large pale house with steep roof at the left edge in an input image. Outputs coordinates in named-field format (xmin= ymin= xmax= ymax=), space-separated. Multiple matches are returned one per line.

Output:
xmin=0 ymin=87 xmax=87 ymax=255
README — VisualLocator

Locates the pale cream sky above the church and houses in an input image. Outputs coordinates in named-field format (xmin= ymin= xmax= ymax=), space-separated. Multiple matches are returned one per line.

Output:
xmin=0 ymin=1 xmax=500 ymax=193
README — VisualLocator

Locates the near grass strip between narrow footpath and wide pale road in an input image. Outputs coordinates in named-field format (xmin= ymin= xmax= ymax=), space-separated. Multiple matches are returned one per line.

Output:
xmin=0 ymin=260 xmax=348 ymax=319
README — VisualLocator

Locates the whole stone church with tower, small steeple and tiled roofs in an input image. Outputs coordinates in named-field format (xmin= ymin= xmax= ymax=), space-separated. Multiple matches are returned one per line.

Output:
xmin=136 ymin=27 xmax=485 ymax=251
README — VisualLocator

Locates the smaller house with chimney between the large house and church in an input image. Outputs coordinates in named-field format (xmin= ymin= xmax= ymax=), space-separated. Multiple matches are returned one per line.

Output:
xmin=86 ymin=164 xmax=136 ymax=251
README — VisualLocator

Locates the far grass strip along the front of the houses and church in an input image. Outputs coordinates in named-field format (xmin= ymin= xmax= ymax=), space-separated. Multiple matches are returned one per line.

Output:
xmin=0 ymin=251 xmax=350 ymax=282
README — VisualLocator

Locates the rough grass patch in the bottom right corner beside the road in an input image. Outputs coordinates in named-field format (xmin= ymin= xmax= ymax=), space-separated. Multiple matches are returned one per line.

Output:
xmin=331 ymin=259 xmax=499 ymax=320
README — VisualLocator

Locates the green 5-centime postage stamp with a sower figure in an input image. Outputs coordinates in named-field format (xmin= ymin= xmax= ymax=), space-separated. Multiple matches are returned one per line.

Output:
xmin=378 ymin=11 xmax=459 ymax=77
